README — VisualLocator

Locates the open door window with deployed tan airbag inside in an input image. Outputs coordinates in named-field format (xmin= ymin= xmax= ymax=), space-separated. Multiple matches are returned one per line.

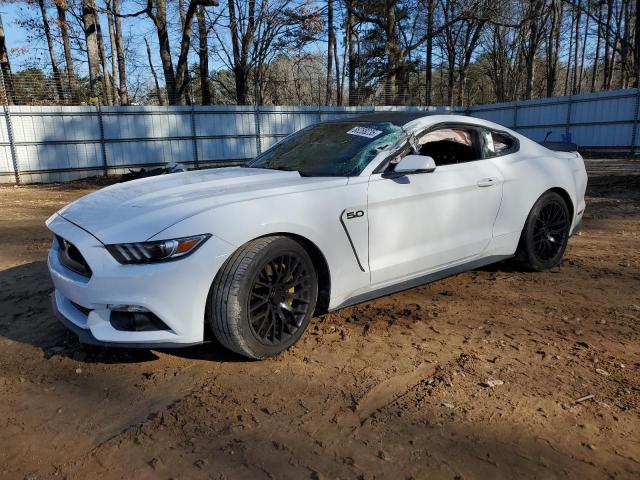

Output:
xmin=418 ymin=126 xmax=482 ymax=166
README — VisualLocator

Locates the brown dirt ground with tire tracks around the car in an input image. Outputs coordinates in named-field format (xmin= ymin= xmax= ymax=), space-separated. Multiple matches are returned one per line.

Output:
xmin=0 ymin=161 xmax=640 ymax=480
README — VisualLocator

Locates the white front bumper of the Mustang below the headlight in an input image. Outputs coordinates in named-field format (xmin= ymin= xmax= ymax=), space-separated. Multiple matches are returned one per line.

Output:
xmin=47 ymin=215 xmax=233 ymax=348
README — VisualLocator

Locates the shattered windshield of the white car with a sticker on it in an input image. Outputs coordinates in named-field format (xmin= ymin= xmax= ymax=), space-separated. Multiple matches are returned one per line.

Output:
xmin=247 ymin=122 xmax=403 ymax=177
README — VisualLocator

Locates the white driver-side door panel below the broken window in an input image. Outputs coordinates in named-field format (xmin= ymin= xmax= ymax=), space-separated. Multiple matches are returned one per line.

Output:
xmin=367 ymin=125 xmax=503 ymax=285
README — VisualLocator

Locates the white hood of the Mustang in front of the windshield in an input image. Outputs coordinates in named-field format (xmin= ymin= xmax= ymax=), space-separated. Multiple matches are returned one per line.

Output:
xmin=57 ymin=167 xmax=348 ymax=244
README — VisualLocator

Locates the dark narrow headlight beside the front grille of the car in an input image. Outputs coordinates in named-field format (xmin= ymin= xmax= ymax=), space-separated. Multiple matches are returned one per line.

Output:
xmin=105 ymin=233 xmax=211 ymax=263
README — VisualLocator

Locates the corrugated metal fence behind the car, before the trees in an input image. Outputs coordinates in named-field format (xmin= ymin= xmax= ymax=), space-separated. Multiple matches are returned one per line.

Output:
xmin=0 ymin=89 xmax=640 ymax=183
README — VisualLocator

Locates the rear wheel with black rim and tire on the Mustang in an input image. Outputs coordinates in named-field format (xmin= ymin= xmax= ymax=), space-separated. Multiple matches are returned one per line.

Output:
xmin=516 ymin=192 xmax=571 ymax=272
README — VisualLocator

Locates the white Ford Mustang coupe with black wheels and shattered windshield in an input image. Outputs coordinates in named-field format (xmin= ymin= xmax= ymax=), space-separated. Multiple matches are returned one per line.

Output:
xmin=47 ymin=112 xmax=587 ymax=358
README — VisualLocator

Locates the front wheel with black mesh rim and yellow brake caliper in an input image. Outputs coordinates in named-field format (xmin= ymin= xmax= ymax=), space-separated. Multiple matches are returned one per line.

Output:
xmin=207 ymin=236 xmax=318 ymax=359
